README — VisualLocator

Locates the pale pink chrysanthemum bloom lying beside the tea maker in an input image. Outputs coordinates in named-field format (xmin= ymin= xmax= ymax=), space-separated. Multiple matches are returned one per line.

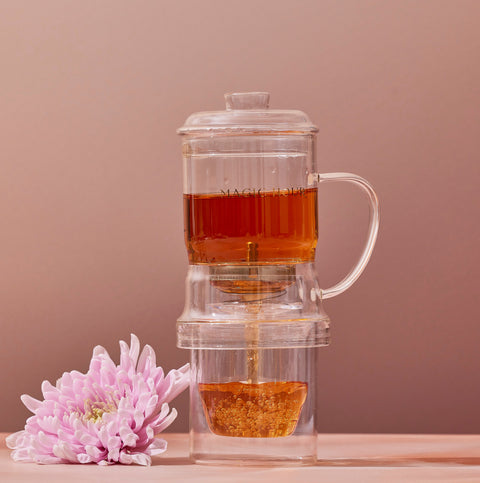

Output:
xmin=7 ymin=334 xmax=190 ymax=465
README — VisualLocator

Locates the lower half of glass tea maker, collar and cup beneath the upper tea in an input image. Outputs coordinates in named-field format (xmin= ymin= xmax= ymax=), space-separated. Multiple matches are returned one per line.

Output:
xmin=177 ymin=263 xmax=330 ymax=465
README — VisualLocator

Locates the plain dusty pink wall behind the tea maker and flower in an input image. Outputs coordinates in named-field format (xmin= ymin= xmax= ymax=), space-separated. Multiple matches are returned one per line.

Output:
xmin=0 ymin=0 xmax=480 ymax=433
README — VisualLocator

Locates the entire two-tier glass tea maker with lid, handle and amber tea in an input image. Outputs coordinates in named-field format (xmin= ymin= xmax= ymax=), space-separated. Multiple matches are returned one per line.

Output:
xmin=177 ymin=92 xmax=379 ymax=464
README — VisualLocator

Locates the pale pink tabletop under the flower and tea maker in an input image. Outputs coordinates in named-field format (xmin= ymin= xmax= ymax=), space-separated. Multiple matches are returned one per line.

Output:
xmin=0 ymin=433 xmax=480 ymax=483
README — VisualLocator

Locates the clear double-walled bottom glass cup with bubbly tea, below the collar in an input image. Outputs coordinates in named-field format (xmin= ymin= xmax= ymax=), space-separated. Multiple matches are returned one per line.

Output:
xmin=190 ymin=347 xmax=318 ymax=465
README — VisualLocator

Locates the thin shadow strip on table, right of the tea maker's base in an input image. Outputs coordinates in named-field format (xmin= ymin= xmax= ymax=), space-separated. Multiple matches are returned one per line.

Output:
xmin=316 ymin=456 xmax=480 ymax=467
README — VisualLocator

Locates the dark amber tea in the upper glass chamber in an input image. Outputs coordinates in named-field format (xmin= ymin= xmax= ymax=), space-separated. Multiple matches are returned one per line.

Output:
xmin=184 ymin=188 xmax=318 ymax=264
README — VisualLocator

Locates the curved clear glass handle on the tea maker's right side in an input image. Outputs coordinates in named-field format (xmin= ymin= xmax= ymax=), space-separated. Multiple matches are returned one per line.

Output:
xmin=309 ymin=173 xmax=380 ymax=299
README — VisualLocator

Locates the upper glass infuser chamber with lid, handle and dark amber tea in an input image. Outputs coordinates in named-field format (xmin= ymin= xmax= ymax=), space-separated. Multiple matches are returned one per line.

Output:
xmin=178 ymin=92 xmax=379 ymax=299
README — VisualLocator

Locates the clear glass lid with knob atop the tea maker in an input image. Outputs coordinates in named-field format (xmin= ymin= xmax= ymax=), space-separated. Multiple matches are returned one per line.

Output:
xmin=177 ymin=92 xmax=318 ymax=134
